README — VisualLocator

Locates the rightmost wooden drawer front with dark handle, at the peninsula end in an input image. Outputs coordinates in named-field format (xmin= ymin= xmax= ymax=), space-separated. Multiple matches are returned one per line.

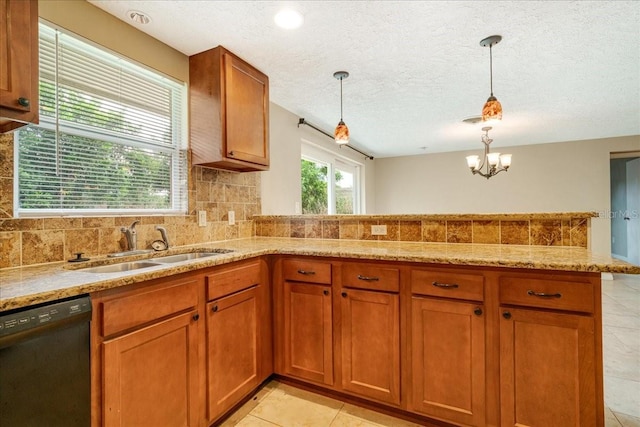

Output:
xmin=500 ymin=277 xmax=595 ymax=313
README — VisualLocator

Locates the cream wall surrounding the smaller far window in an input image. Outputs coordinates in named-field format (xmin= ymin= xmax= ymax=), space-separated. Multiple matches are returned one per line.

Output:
xmin=261 ymin=103 xmax=375 ymax=215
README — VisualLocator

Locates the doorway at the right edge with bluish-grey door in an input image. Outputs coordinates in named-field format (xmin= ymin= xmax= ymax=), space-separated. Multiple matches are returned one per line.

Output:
xmin=610 ymin=152 xmax=640 ymax=265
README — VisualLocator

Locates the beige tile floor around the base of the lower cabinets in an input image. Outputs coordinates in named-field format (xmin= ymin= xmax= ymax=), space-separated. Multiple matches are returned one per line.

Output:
xmin=222 ymin=275 xmax=640 ymax=427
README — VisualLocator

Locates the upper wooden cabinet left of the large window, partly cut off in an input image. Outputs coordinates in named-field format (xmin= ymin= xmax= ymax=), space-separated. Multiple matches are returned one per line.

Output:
xmin=0 ymin=0 xmax=38 ymax=133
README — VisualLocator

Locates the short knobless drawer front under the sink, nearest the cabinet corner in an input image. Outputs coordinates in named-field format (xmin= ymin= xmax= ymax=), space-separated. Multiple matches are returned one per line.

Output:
xmin=207 ymin=261 xmax=261 ymax=301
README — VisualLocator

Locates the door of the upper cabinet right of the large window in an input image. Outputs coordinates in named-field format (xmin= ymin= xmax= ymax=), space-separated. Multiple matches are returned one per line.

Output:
xmin=223 ymin=52 xmax=269 ymax=166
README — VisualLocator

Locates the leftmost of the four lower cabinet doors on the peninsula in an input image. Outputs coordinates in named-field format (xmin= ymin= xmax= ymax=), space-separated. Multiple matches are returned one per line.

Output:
xmin=284 ymin=282 xmax=333 ymax=385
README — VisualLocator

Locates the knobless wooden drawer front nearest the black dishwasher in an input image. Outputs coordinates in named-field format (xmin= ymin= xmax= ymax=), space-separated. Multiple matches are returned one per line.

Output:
xmin=102 ymin=280 xmax=198 ymax=337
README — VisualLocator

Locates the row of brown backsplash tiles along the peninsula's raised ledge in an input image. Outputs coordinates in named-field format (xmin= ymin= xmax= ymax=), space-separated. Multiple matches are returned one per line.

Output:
xmin=254 ymin=212 xmax=597 ymax=248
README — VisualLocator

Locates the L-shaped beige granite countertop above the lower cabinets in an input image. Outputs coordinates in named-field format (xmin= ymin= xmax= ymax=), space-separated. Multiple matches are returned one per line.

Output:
xmin=0 ymin=237 xmax=640 ymax=311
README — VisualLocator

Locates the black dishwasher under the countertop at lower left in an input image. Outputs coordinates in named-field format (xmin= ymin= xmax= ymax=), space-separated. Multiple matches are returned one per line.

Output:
xmin=0 ymin=296 xmax=91 ymax=427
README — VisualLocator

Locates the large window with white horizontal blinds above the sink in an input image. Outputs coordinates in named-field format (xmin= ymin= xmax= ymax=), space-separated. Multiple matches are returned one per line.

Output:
xmin=15 ymin=23 xmax=187 ymax=216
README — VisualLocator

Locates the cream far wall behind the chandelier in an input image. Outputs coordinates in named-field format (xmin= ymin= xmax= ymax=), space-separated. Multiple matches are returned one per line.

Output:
xmin=368 ymin=135 xmax=640 ymax=255
